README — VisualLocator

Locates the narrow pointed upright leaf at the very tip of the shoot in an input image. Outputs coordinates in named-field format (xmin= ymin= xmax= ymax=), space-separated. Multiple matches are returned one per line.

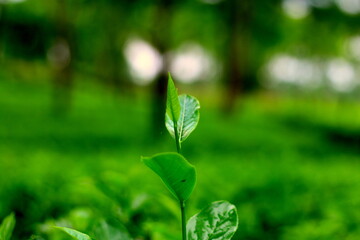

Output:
xmin=166 ymin=73 xmax=180 ymax=122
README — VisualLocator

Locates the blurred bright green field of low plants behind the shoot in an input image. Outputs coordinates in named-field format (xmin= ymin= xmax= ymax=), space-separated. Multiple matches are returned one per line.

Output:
xmin=0 ymin=80 xmax=360 ymax=240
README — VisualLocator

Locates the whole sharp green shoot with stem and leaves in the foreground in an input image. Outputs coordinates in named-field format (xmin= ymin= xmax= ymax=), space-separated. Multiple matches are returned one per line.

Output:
xmin=142 ymin=74 xmax=238 ymax=240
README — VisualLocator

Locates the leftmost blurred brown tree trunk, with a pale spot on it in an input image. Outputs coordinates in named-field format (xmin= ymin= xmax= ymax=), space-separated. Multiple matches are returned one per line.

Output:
xmin=48 ymin=0 xmax=74 ymax=115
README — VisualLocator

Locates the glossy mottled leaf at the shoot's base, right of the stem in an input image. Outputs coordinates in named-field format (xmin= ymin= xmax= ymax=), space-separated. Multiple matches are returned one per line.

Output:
xmin=187 ymin=201 xmax=238 ymax=240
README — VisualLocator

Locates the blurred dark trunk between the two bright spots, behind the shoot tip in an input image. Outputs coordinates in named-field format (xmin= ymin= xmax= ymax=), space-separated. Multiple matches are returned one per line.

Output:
xmin=152 ymin=0 xmax=173 ymax=137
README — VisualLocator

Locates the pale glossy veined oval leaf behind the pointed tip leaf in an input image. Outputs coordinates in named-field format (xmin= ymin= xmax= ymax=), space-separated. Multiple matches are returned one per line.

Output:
xmin=165 ymin=94 xmax=200 ymax=142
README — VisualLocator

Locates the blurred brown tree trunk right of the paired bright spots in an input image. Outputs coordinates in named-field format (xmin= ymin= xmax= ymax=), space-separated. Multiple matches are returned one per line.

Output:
xmin=223 ymin=0 xmax=252 ymax=114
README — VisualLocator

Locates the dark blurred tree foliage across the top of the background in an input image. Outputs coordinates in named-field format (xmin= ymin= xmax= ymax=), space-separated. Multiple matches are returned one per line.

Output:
xmin=0 ymin=0 xmax=360 ymax=92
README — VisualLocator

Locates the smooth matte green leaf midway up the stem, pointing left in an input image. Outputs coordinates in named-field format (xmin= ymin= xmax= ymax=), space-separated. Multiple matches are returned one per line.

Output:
xmin=142 ymin=153 xmax=196 ymax=201
